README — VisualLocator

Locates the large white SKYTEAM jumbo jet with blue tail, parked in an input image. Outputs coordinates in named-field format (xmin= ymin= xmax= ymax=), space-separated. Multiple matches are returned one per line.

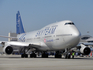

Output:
xmin=0 ymin=11 xmax=90 ymax=59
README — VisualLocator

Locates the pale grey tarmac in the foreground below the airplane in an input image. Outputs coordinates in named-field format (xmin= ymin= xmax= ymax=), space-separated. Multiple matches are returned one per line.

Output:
xmin=0 ymin=55 xmax=93 ymax=70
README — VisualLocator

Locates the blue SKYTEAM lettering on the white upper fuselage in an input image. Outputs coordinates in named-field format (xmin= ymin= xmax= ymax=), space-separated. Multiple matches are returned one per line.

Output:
xmin=36 ymin=25 xmax=58 ymax=37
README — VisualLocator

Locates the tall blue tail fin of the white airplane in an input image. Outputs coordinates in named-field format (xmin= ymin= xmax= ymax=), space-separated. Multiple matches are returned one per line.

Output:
xmin=16 ymin=11 xmax=25 ymax=34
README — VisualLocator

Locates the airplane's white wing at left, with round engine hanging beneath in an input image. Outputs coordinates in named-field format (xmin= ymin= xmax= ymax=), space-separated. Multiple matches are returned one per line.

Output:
xmin=0 ymin=41 xmax=46 ymax=54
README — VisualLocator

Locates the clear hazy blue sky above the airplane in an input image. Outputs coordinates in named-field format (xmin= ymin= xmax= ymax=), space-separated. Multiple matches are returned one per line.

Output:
xmin=0 ymin=0 xmax=93 ymax=41
